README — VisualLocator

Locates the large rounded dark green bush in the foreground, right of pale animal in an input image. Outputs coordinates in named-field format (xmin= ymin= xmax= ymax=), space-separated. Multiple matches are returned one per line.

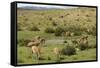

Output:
xmin=61 ymin=45 xmax=76 ymax=56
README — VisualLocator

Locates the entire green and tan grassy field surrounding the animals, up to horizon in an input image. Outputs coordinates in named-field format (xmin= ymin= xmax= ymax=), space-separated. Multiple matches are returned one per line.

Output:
xmin=17 ymin=7 xmax=96 ymax=64
